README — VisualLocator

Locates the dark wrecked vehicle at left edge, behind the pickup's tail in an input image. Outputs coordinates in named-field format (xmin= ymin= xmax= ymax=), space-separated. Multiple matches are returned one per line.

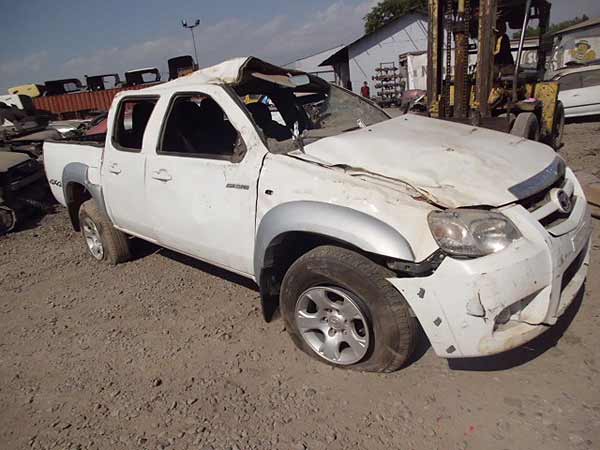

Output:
xmin=0 ymin=149 xmax=48 ymax=236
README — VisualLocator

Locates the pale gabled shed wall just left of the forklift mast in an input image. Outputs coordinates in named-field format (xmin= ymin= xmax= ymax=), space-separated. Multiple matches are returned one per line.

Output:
xmin=348 ymin=14 xmax=427 ymax=95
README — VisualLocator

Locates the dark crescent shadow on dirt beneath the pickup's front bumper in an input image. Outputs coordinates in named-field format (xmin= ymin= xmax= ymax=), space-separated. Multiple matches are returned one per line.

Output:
xmin=448 ymin=285 xmax=585 ymax=372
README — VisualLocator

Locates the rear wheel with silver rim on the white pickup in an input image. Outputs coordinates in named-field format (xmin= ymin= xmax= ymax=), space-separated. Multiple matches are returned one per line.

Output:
xmin=79 ymin=200 xmax=131 ymax=265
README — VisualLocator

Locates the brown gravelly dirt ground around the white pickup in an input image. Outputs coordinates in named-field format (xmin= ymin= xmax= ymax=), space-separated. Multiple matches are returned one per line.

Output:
xmin=0 ymin=122 xmax=600 ymax=450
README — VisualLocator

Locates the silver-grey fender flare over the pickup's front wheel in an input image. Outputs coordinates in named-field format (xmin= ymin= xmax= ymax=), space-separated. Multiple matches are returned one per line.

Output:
xmin=254 ymin=201 xmax=414 ymax=279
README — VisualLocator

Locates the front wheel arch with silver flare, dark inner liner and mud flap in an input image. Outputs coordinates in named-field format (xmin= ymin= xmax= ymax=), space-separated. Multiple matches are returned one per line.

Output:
xmin=254 ymin=201 xmax=414 ymax=321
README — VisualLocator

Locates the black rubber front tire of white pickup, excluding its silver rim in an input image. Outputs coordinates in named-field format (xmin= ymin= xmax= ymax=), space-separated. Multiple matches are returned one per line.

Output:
xmin=280 ymin=246 xmax=418 ymax=372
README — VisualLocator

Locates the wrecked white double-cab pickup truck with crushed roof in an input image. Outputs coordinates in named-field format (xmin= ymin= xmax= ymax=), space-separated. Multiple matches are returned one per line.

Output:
xmin=44 ymin=58 xmax=591 ymax=371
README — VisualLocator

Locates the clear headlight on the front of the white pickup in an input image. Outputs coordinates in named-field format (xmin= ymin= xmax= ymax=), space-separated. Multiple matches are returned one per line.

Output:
xmin=427 ymin=209 xmax=521 ymax=258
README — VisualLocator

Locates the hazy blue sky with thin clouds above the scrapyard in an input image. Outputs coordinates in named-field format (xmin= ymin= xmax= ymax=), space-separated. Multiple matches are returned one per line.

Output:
xmin=0 ymin=0 xmax=600 ymax=93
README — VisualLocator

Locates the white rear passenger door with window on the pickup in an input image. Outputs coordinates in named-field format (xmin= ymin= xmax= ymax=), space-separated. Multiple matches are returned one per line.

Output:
xmin=102 ymin=96 xmax=158 ymax=240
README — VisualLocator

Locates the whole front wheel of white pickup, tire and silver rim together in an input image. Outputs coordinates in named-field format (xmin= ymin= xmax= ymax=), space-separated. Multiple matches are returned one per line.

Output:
xmin=280 ymin=246 xmax=418 ymax=372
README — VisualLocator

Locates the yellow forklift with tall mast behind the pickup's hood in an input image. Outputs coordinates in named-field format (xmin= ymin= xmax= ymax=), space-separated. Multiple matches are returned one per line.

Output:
xmin=427 ymin=0 xmax=565 ymax=150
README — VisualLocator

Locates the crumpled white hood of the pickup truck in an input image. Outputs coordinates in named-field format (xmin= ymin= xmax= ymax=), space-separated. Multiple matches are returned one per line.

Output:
xmin=290 ymin=114 xmax=556 ymax=208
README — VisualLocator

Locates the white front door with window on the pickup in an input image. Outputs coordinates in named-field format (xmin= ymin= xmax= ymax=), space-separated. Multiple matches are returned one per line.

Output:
xmin=147 ymin=86 xmax=266 ymax=274
